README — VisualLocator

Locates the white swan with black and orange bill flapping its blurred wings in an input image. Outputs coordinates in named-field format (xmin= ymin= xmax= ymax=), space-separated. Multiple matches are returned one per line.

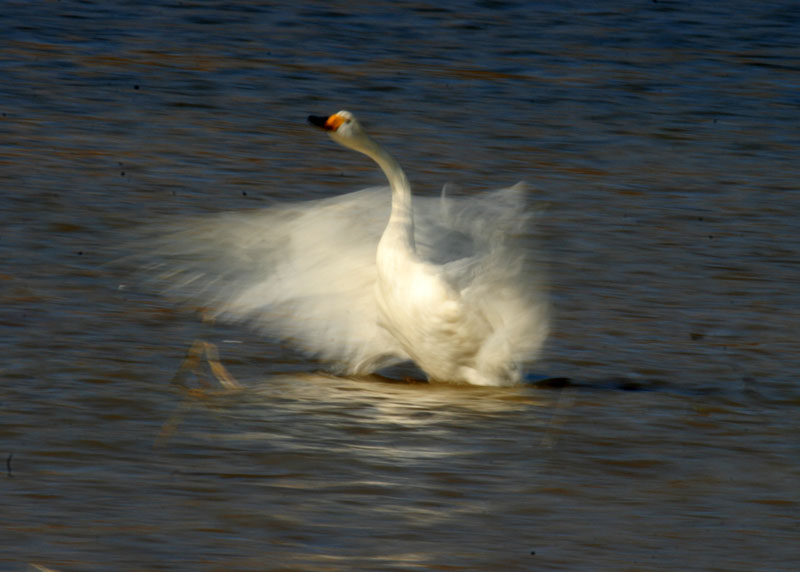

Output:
xmin=141 ymin=111 xmax=548 ymax=386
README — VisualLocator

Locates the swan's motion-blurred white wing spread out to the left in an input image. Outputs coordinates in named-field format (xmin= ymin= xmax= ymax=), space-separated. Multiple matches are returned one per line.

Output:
xmin=141 ymin=188 xmax=408 ymax=374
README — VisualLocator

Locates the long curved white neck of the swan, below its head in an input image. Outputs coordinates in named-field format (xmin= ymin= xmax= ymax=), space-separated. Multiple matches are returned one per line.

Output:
xmin=359 ymin=139 xmax=415 ymax=252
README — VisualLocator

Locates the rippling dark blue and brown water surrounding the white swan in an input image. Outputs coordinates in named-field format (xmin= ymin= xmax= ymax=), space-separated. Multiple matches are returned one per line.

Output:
xmin=0 ymin=1 xmax=800 ymax=571
